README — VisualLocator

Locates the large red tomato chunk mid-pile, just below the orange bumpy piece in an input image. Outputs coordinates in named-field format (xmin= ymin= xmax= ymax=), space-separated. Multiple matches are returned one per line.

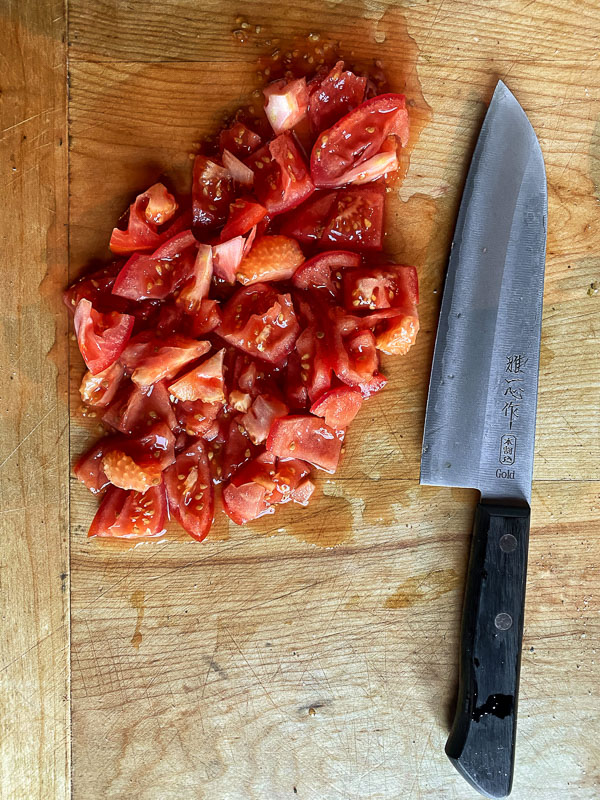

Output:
xmin=217 ymin=283 xmax=300 ymax=364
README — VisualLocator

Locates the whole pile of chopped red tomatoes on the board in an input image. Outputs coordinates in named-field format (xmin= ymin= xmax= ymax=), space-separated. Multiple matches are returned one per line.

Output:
xmin=64 ymin=62 xmax=419 ymax=541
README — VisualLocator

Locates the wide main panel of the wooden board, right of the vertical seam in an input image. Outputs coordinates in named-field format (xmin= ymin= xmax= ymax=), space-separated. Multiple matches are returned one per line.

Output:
xmin=62 ymin=0 xmax=600 ymax=800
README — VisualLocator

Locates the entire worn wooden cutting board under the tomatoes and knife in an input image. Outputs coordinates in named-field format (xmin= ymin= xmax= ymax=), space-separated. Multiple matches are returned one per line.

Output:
xmin=0 ymin=0 xmax=600 ymax=800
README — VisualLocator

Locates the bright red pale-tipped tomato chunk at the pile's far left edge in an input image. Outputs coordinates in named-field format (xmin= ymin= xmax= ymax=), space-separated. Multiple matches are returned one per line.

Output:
xmin=73 ymin=298 xmax=134 ymax=375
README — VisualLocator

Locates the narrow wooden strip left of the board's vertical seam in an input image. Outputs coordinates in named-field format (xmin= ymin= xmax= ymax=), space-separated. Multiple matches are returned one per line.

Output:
xmin=0 ymin=0 xmax=70 ymax=800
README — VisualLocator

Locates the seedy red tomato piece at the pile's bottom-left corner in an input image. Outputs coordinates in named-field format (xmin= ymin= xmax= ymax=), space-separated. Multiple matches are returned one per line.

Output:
xmin=88 ymin=483 xmax=167 ymax=539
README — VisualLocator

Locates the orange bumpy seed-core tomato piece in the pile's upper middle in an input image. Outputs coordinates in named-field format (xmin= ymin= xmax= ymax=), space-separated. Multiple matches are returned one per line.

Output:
xmin=236 ymin=236 xmax=304 ymax=285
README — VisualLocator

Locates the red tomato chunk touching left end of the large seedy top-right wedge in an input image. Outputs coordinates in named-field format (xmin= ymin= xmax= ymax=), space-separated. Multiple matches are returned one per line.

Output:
xmin=248 ymin=133 xmax=315 ymax=216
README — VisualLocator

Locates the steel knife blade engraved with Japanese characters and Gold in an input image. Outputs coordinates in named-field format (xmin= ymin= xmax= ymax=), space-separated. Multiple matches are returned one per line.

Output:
xmin=421 ymin=81 xmax=547 ymax=502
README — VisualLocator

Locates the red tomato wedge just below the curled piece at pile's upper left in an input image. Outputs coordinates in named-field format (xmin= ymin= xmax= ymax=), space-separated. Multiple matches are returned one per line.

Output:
xmin=113 ymin=231 xmax=198 ymax=300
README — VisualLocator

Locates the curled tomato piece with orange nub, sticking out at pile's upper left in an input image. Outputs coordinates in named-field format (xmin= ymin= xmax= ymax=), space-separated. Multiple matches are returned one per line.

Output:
xmin=110 ymin=183 xmax=177 ymax=254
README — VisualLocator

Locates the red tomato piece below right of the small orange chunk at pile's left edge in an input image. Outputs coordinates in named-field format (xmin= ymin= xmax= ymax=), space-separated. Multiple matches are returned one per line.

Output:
xmin=102 ymin=381 xmax=177 ymax=434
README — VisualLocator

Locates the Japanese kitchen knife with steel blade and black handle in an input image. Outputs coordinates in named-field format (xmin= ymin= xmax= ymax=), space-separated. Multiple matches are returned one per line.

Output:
xmin=421 ymin=81 xmax=547 ymax=798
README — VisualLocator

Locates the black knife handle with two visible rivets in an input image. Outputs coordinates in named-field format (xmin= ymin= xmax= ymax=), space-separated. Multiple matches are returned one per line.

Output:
xmin=446 ymin=503 xmax=530 ymax=798
